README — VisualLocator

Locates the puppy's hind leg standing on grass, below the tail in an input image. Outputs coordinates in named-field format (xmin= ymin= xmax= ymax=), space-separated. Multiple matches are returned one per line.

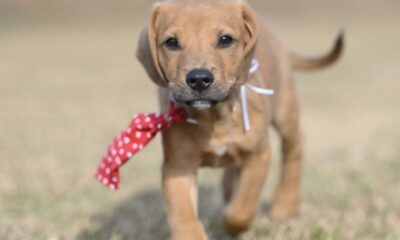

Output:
xmin=272 ymin=80 xmax=302 ymax=220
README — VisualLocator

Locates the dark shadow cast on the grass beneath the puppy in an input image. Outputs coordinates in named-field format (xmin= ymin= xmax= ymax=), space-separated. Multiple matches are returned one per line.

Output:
xmin=77 ymin=186 xmax=236 ymax=240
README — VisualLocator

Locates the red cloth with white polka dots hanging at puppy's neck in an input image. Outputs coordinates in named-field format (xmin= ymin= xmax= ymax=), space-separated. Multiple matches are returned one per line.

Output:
xmin=96 ymin=102 xmax=187 ymax=190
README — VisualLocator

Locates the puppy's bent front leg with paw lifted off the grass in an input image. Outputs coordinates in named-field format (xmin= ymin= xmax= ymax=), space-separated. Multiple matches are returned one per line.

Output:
xmin=224 ymin=147 xmax=270 ymax=236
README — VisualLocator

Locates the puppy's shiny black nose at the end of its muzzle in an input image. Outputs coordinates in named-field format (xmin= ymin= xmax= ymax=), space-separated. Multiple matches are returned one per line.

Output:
xmin=186 ymin=68 xmax=214 ymax=92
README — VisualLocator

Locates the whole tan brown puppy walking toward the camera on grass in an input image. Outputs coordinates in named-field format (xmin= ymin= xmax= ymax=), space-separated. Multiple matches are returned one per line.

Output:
xmin=137 ymin=0 xmax=343 ymax=240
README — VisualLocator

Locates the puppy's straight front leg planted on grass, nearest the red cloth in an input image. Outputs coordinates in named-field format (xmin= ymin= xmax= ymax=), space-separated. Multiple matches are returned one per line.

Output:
xmin=162 ymin=128 xmax=207 ymax=240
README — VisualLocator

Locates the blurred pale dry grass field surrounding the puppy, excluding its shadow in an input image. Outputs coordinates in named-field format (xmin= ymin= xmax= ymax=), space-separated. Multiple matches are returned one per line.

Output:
xmin=0 ymin=0 xmax=400 ymax=240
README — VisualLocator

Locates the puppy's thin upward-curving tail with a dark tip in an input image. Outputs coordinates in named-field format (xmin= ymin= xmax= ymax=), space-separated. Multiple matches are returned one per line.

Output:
xmin=290 ymin=31 xmax=344 ymax=70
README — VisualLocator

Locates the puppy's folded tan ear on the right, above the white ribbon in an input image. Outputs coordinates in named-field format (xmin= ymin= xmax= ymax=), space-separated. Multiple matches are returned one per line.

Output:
xmin=237 ymin=1 xmax=258 ymax=84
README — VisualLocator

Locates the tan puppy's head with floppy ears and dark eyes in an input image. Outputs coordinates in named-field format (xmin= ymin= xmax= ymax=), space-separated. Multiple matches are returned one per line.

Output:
xmin=137 ymin=0 xmax=258 ymax=109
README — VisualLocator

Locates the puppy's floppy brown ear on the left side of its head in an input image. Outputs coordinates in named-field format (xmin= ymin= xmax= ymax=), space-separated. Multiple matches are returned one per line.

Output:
xmin=136 ymin=3 xmax=168 ymax=87
